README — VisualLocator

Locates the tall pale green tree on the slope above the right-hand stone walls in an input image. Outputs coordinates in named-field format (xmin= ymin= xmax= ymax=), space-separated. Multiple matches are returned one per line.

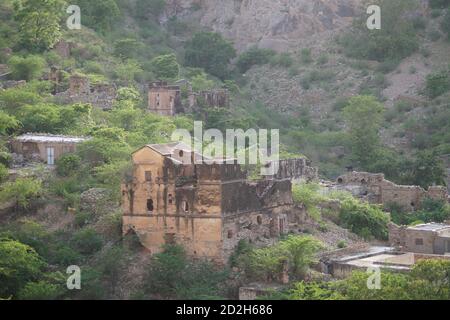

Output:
xmin=343 ymin=96 xmax=384 ymax=168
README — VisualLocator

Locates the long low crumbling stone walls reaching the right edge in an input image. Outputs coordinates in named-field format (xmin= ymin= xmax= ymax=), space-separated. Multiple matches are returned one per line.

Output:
xmin=331 ymin=172 xmax=448 ymax=211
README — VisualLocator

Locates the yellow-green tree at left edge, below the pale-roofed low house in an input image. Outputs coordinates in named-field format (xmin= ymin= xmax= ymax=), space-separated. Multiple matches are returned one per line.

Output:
xmin=0 ymin=178 xmax=42 ymax=209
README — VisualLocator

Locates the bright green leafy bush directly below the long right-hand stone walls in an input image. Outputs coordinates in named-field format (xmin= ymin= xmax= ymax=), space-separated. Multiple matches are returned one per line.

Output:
xmin=339 ymin=198 xmax=389 ymax=240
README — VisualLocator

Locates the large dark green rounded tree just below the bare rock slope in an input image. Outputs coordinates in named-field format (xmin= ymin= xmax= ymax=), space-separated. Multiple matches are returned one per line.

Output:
xmin=185 ymin=32 xmax=236 ymax=79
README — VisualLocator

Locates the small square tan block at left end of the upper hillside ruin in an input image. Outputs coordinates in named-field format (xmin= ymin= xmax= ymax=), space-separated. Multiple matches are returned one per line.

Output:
xmin=148 ymin=81 xmax=182 ymax=116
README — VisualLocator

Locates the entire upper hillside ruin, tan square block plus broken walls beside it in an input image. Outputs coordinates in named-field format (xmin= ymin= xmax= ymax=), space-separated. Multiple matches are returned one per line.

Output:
xmin=148 ymin=80 xmax=230 ymax=116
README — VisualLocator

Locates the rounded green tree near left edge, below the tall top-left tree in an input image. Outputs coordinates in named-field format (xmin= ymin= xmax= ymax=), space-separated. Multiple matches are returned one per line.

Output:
xmin=8 ymin=56 xmax=45 ymax=81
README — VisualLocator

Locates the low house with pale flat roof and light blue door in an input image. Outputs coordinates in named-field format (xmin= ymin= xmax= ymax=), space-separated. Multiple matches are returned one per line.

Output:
xmin=11 ymin=133 xmax=88 ymax=165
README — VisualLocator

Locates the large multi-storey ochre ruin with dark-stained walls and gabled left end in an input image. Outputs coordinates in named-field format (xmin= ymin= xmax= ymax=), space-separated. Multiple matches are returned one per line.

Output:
xmin=122 ymin=143 xmax=314 ymax=262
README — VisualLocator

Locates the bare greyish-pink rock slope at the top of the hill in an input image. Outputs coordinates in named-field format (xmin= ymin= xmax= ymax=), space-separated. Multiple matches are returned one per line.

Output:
xmin=161 ymin=0 xmax=362 ymax=51
